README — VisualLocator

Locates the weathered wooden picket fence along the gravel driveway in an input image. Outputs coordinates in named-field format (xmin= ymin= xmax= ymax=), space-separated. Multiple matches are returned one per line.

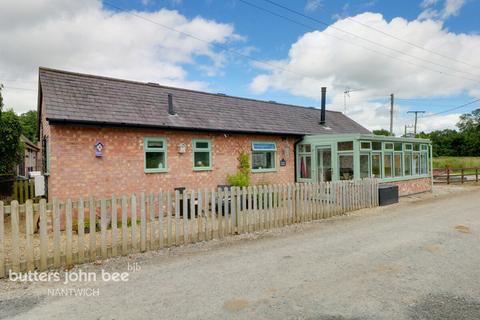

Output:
xmin=0 ymin=179 xmax=378 ymax=278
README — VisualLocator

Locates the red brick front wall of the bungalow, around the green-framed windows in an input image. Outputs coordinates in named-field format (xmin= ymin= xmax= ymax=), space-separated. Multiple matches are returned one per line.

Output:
xmin=48 ymin=125 xmax=296 ymax=200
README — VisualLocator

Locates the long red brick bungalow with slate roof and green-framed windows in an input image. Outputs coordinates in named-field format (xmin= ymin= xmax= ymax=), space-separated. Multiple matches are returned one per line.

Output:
xmin=38 ymin=68 xmax=429 ymax=200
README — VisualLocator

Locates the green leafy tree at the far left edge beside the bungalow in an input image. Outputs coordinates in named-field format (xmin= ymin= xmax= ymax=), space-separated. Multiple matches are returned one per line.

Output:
xmin=0 ymin=87 xmax=23 ymax=174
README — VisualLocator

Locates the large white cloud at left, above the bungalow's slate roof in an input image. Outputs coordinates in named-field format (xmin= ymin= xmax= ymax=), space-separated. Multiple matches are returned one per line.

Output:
xmin=0 ymin=0 xmax=243 ymax=112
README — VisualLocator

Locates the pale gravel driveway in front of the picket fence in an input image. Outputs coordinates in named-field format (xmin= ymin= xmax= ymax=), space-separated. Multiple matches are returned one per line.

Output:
xmin=0 ymin=187 xmax=480 ymax=320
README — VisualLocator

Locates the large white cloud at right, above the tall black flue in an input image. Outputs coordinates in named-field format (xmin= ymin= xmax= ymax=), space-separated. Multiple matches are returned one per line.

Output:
xmin=251 ymin=13 xmax=480 ymax=133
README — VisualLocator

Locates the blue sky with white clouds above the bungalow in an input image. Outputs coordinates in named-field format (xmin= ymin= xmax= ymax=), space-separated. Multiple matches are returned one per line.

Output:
xmin=0 ymin=0 xmax=480 ymax=135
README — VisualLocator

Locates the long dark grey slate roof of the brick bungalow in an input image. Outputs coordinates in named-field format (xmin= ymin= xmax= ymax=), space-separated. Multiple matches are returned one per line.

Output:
xmin=39 ymin=68 xmax=370 ymax=135
